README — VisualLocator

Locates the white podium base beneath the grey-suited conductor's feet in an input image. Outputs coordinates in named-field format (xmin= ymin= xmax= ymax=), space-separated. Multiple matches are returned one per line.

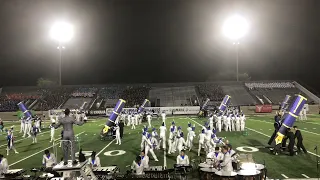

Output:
xmin=53 ymin=160 xmax=97 ymax=180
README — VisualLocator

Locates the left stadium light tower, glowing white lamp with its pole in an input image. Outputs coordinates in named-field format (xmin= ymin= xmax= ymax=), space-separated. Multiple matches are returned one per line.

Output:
xmin=50 ymin=22 xmax=73 ymax=86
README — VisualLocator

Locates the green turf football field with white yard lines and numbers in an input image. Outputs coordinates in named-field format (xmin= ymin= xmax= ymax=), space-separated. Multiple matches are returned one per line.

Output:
xmin=0 ymin=115 xmax=320 ymax=179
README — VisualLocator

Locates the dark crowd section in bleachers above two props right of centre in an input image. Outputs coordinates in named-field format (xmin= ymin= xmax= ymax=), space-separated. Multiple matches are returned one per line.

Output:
xmin=197 ymin=84 xmax=224 ymax=101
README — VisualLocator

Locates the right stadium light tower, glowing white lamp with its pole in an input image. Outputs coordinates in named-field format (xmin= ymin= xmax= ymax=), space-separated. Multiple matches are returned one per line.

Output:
xmin=223 ymin=15 xmax=249 ymax=81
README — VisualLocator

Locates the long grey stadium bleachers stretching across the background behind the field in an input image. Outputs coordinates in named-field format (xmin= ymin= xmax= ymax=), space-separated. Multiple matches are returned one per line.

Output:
xmin=0 ymin=81 xmax=318 ymax=111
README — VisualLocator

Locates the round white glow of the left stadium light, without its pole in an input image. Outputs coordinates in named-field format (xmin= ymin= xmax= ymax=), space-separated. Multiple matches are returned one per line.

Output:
xmin=50 ymin=22 xmax=73 ymax=43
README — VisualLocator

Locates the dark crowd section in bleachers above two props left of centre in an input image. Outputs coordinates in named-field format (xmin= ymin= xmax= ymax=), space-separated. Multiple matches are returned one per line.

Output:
xmin=120 ymin=86 xmax=150 ymax=107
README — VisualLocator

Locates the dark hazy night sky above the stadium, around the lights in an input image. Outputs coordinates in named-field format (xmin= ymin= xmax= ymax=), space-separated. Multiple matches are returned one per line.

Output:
xmin=0 ymin=0 xmax=320 ymax=91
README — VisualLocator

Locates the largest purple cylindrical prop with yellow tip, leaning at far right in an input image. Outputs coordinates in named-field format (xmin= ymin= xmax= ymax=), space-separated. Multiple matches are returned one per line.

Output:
xmin=275 ymin=95 xmax=307 ymax=145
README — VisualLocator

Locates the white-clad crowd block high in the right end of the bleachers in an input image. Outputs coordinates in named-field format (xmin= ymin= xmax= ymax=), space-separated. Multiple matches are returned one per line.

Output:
xmin=245 ymin=82 xmax=295 ymax=90
